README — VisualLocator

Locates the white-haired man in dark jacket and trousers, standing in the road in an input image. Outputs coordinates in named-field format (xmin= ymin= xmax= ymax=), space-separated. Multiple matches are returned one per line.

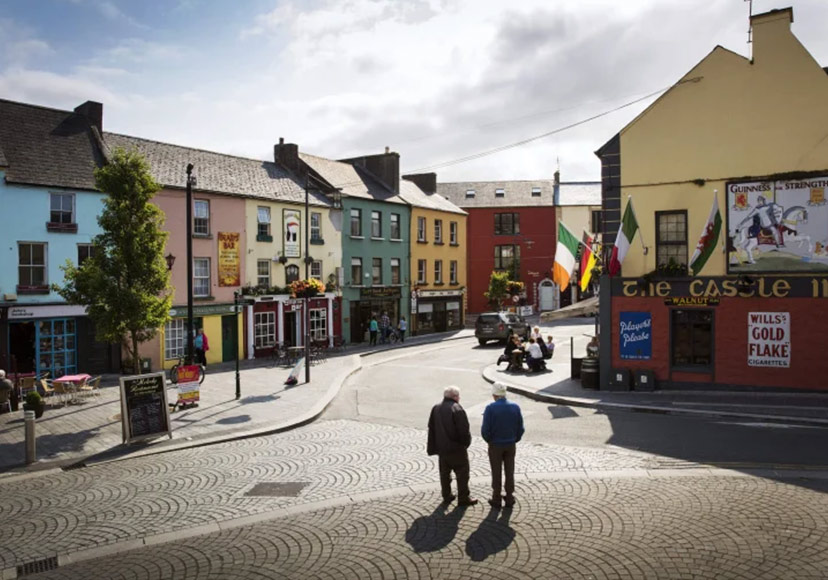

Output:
xmin=427 ymin=386 xmax=477 ymax=506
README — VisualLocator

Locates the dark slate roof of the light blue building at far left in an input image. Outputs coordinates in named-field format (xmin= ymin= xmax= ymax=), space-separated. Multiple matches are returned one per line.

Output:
xmin=0 ymin=99 xmax=104 ymax=190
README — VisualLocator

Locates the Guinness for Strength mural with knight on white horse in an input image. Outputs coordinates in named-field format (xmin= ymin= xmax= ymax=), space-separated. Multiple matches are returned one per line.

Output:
xmin=727 ymin=177 xmax=828 ymax=274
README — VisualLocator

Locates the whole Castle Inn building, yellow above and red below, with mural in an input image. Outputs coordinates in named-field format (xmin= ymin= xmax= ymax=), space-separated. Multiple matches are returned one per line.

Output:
xmin=597 ymin=8 xmax=828 ymax=389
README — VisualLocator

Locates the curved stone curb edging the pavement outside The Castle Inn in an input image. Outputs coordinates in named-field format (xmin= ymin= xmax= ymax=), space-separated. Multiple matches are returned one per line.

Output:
xmin=481 ymin=367 xmax=828 ymax=427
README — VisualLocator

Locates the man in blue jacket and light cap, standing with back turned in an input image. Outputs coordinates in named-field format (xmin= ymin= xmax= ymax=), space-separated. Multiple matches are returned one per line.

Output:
xmin=480 ymin=383 xmax=524 ymax=509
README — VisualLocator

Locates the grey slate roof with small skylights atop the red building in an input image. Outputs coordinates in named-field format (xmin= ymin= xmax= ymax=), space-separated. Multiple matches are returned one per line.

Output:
xmin=437 ymin=179 xmax=555 ymax=209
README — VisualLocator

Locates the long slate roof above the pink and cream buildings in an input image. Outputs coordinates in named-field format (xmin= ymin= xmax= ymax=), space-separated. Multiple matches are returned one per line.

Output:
xmin=104 ymin=132 xmax=331 ymax=206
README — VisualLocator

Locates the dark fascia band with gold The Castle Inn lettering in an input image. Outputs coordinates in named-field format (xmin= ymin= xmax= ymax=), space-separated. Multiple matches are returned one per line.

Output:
xmin=612 ymin=276 xmax=828 ymax=304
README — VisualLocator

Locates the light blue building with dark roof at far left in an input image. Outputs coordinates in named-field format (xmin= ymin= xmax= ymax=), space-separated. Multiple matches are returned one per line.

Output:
xmin=0 ymin=100 xmax=120 ymax=377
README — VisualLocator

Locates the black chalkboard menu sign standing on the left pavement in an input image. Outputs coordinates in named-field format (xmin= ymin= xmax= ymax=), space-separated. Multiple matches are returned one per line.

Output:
xmin=121 ymin=373 xmax=172 ymax=443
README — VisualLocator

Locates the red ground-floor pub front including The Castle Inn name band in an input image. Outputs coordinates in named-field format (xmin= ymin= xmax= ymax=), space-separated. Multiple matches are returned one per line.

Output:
xmin=602 ymin=275 xmax=828 ymax=391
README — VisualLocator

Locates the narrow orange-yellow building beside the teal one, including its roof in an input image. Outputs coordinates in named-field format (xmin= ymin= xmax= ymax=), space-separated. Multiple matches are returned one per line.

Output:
xmin=400 ymin=173 xmax=467 ymax=335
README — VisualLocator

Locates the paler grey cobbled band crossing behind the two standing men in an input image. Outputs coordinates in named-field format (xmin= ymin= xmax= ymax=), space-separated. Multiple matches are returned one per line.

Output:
xmin=0 ymin=420 xmax=695 ymax=570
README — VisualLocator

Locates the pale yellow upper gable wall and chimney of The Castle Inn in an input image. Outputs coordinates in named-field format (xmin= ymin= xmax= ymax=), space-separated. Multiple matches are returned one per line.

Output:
xmin=620 ymin=12 xmax=828 ymax=276
